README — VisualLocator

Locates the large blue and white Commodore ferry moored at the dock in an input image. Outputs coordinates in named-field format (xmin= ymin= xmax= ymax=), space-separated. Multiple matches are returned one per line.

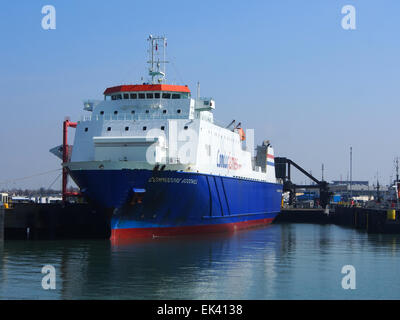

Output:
xmin=50 ymin=35 xmax=282 ymax=240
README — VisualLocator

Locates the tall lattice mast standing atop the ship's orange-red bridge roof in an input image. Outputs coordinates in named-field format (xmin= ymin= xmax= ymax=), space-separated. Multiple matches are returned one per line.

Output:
xmin=147 ymin=35 xmax=168 ymax=84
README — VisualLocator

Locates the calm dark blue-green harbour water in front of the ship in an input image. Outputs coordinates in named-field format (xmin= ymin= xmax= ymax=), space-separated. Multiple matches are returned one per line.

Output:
xmin=0 ymin=224 xmax=400 ymax=299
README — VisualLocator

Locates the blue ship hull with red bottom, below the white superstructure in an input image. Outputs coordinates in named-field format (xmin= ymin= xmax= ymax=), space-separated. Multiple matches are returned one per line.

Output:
xmin=70 ymin=170 xmax=282 ymax=239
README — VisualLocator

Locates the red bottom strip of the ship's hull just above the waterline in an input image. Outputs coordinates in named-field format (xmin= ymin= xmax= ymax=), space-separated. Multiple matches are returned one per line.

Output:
xmin=111 ymin=218 xmax=274 ymax=240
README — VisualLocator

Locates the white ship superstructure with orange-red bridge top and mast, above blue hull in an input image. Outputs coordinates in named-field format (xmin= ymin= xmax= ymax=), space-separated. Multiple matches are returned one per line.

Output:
xmin=64 ymin=36 xmax=276 ymax=183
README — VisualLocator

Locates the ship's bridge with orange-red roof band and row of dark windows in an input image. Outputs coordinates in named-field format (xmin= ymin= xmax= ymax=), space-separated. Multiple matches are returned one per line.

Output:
xmin=104 ymin=84 xmax=190 ymax=100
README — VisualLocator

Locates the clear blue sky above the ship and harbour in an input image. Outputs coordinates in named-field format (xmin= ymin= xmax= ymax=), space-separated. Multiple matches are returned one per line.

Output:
xmin=0 ymin=0 xmax=400 ymax=188
